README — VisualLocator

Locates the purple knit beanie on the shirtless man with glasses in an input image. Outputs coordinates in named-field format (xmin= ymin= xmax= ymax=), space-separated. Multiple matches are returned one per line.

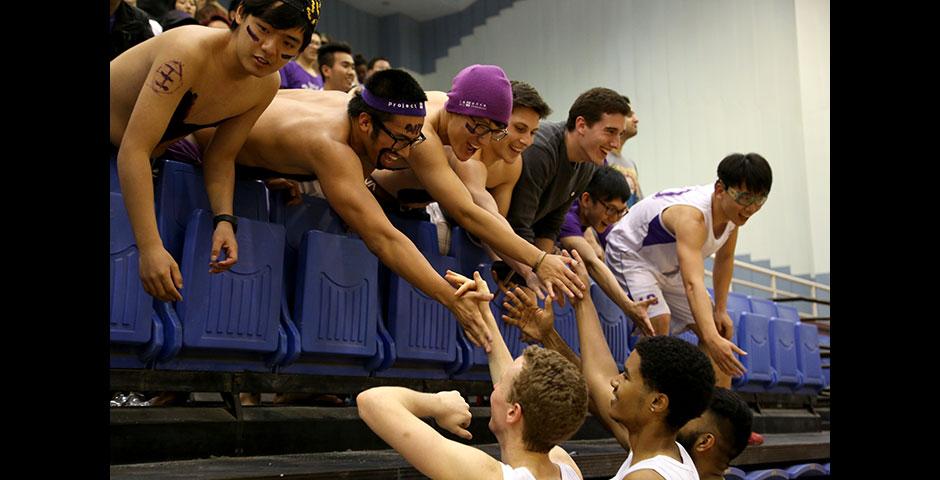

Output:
xmin=444 ymin=65 xmax=512 ymax=125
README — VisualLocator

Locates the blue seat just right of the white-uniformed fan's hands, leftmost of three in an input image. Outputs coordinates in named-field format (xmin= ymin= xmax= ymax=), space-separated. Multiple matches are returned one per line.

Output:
xmin=732 ymin=312 xmax=776 ymax=392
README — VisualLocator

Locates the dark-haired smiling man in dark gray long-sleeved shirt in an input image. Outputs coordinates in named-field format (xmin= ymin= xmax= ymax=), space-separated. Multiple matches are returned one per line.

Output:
xmin=506 ymin=87 xmax=631 ymax=296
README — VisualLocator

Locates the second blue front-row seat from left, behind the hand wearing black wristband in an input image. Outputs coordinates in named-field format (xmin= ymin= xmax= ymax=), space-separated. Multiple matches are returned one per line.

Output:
xmin=157 ymin=209 xmax=287 ymax=371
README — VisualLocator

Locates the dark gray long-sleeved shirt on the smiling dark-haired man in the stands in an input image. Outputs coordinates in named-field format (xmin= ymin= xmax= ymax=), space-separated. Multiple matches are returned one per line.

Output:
xmin=506 ymin=122 xmax=597 ymax=243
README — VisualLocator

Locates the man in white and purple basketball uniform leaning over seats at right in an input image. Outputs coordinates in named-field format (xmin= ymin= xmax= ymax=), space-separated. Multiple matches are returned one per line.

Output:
xmin=605 ymin=153 xmax=773 ymax=388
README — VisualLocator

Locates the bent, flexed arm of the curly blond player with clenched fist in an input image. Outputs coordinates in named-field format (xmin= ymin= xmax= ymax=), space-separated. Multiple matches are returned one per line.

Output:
xmin=356 ymin=387 xmax=502 ymax=480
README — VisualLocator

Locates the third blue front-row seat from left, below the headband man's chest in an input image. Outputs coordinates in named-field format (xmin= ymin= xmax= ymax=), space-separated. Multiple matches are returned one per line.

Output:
xmin=278 ymin=230 xmax=394 ymax=376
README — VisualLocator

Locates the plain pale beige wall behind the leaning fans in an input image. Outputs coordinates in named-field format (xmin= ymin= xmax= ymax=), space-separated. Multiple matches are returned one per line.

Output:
xmin=420 ymin=0 xmax=829 ymax=274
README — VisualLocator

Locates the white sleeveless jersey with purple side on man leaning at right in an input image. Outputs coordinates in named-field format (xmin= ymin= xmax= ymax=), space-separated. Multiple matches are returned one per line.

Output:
xmin=607 ymin=184 xmax=735 ymax=277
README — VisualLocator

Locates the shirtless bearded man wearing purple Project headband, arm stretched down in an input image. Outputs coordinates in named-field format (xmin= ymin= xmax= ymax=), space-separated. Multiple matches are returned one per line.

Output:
xmin=196 ymin=69 xmax=500 ymax=350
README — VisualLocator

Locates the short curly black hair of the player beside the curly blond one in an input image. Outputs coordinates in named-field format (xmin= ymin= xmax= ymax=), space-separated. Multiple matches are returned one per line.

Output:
xmin=636 ymin=336 xmax=715 ymax=432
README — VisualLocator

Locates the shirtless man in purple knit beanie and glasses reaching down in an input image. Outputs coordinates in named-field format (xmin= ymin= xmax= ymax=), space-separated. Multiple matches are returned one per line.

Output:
xmin=372 ymin=65 xmax=584 ymax=297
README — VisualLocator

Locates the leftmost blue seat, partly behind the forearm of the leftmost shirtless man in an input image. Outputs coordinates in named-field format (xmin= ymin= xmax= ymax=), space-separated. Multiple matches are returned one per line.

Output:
xmin=109 ymin=193 xmax=164 ymax=368
